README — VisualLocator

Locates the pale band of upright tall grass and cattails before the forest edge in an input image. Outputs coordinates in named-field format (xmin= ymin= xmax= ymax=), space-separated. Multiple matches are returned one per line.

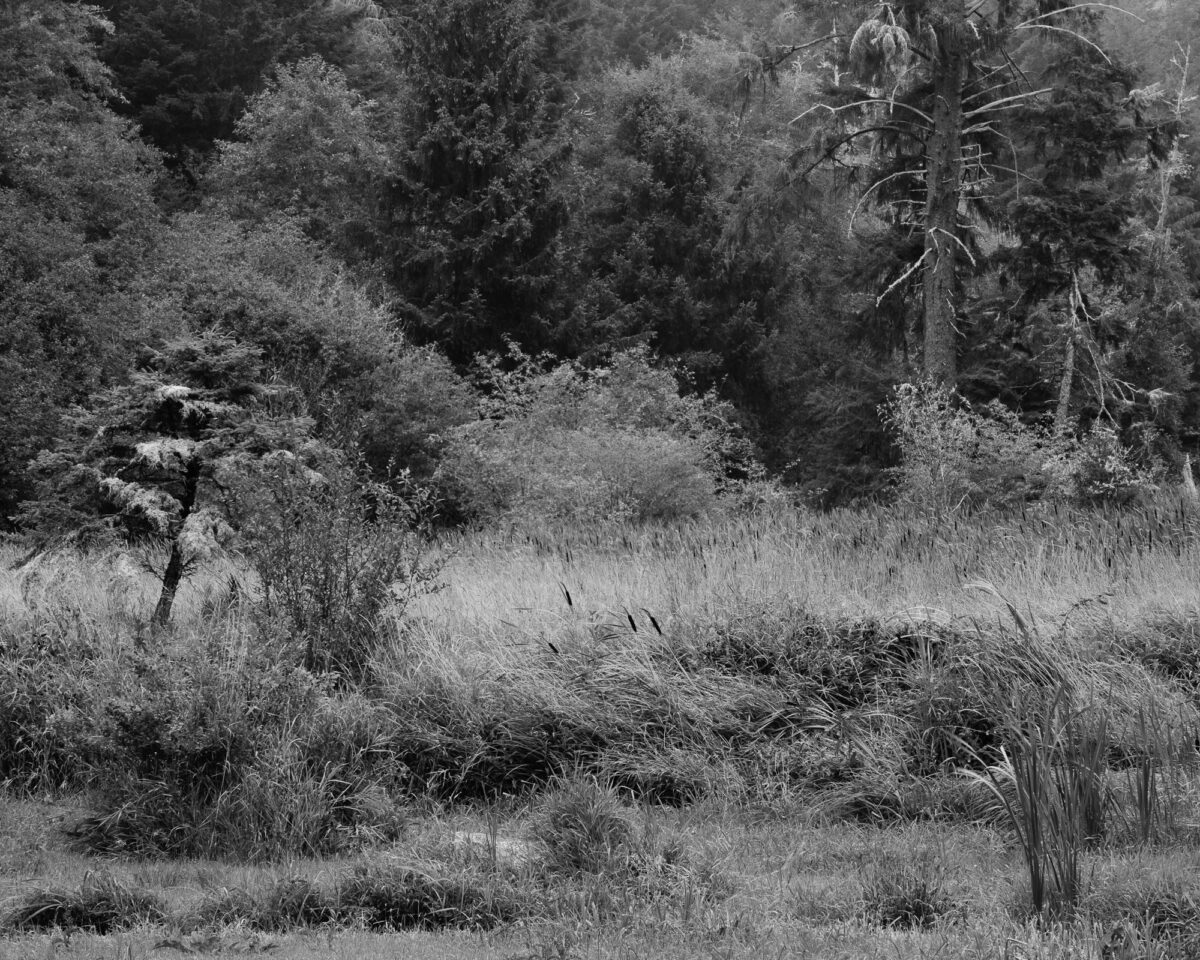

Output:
xmin=413 ymin=498 xmax=1200 ymax=644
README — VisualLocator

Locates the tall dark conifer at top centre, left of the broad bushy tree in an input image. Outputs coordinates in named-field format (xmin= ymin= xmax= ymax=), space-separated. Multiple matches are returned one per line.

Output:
xmin=388 ymin=0 xmax=568 ymax=361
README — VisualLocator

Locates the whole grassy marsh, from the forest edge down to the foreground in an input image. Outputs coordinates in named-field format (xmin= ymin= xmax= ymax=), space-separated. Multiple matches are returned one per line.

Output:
xmin=0 ymin=500 xmax=1200 ymax=960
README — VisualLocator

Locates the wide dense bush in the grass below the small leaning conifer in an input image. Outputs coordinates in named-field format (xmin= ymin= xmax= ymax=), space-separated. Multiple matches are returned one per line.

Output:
xmin=47 ymin=649 xmax=407 ymax=860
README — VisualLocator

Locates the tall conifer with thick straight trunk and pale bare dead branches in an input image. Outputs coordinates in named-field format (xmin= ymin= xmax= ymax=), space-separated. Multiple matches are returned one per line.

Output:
xmin=792 ymin=0 xmax=1137 ymax=385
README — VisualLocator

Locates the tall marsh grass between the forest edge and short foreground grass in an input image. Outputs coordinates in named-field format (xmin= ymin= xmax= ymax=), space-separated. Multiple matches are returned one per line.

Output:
xmin=0 ymin=502 xmax=1200 ymax=864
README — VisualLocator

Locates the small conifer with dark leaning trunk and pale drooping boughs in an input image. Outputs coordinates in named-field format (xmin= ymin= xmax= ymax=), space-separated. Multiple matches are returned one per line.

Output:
xmin=24 ymin=331 xmax=310 ymax=626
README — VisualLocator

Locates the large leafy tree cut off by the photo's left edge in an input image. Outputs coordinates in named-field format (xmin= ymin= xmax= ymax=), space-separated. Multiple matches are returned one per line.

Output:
xmin=0 ymin=2 xmax=158 ymax=516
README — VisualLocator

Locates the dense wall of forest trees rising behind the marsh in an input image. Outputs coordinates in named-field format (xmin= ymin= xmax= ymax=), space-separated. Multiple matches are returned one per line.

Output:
xmin=0 ymin=0 xmax=1200 ymax=528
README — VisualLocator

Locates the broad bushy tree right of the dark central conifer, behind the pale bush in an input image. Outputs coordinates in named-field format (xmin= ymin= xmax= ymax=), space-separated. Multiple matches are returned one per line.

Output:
xmin=554 ymin=64 xmax=792 ymax=396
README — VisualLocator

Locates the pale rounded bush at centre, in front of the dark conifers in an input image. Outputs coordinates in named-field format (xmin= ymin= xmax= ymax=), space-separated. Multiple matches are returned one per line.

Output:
xmin=438 ymin=352 xmax=752 ymax=522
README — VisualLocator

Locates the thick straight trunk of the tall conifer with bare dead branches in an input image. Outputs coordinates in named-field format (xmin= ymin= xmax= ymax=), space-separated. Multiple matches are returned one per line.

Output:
xmin=924 ymin=8 xmax=966 ymax=386
